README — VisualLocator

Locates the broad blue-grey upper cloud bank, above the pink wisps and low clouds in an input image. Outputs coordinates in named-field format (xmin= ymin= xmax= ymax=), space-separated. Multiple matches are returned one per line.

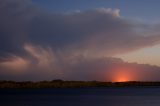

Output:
xmin=0 ymin=0 xmax=160 ymax=56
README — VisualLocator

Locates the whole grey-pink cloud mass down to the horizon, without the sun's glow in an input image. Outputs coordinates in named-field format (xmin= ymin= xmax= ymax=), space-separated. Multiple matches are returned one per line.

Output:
xmin=0 ymin=0 xmax=160 ymax=80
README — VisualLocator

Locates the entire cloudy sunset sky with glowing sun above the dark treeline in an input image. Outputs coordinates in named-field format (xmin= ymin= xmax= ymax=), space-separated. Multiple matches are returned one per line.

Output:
xmin=0 ymin=0 xmax=160 ymax=81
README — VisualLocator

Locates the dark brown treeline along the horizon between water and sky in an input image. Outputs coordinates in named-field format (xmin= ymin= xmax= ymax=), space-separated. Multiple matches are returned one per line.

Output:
xmin=0 ymin=80 xmax=160 ymax=88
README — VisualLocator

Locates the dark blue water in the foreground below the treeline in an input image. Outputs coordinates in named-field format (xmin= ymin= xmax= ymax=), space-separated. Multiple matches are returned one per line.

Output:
xmin=0 ymin=88 xmax=160 ymax=106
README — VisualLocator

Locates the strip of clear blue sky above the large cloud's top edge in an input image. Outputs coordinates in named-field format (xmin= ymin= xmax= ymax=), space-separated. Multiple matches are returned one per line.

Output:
xmin=32 ymin=0 xmax=160 ymax=21
